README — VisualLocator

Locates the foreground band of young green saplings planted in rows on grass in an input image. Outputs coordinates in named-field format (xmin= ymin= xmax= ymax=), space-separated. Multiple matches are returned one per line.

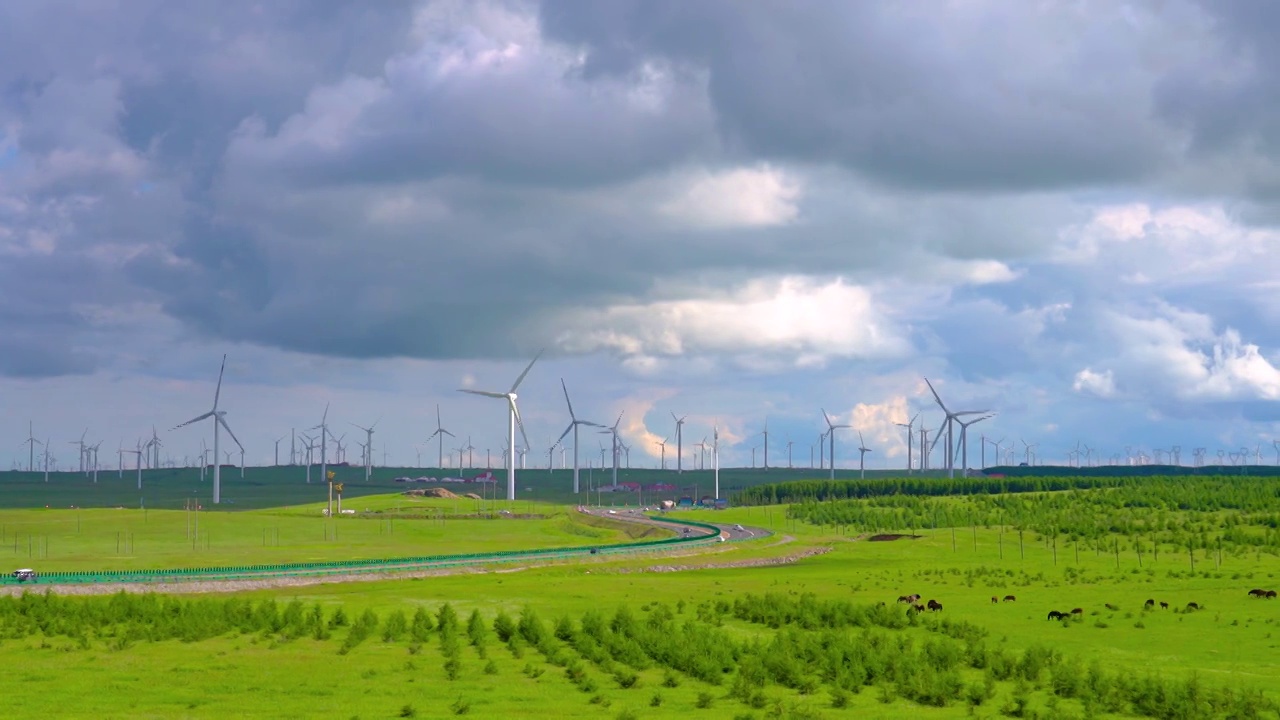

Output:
xmin=0 ymin=593 xmax=1280 ymax=717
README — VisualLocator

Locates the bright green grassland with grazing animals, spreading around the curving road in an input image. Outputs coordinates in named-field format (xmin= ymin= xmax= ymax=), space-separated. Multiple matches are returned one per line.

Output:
xmin=0 ymin=474 xmax=1280 ymax=717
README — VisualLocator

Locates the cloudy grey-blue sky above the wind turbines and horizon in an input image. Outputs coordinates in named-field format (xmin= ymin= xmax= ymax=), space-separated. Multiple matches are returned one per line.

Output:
xmin=0 ymin=0 xmax=1280 ymax=469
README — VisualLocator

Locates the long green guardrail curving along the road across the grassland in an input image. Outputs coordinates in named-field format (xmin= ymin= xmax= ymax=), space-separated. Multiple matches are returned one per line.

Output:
xmin=0 ymin=516 xmax=721 ymax=585
